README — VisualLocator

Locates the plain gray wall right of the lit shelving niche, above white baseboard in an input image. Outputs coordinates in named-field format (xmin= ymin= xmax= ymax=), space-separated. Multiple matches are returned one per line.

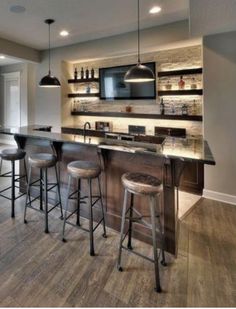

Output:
xmin=203 ymin=32 xmax=236 ymax=196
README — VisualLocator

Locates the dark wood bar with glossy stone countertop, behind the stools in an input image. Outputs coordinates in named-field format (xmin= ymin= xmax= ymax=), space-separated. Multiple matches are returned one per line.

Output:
xmin=0 ymin=125 xmax=215 ymax=255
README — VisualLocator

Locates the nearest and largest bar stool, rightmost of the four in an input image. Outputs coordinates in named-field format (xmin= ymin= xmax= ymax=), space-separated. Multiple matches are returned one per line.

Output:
xmin=117 ymin=173 xmax=166 ymax=292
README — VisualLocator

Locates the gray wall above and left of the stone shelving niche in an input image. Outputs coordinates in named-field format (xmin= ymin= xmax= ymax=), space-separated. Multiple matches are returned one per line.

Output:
xmin=35 ymin=21 xmax=189 ymax=129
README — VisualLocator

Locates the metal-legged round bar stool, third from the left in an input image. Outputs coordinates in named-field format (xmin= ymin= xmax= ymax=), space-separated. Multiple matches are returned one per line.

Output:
xmin=62 ymin=161 xmax=106 ymax=256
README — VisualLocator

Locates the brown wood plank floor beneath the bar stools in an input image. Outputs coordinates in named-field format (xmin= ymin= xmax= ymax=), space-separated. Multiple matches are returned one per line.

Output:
xmin=0 ymin=171 xmax=236 ymax=307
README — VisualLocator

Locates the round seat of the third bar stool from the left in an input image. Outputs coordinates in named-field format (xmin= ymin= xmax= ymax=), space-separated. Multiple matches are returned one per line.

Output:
xmin=67 ymin=161 xmax=101 ymax=178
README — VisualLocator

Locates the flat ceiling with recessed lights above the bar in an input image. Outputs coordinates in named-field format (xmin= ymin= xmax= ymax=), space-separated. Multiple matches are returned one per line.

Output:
xmin=0 ymin=0 xmax=189 ymax=50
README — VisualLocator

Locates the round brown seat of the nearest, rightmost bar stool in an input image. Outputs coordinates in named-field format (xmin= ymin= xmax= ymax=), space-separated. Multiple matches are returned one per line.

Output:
xmin=121 ymin=173 xmax=163 ymax=194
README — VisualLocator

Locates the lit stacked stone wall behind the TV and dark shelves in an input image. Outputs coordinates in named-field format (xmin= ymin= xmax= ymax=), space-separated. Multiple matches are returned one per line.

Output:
xmin=62 ymin=46 xmax=203 ymax=135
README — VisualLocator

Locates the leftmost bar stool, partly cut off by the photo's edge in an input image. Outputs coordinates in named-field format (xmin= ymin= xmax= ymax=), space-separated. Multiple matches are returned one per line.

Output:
xmin=0 ymin=148 xmax=27 ymax=218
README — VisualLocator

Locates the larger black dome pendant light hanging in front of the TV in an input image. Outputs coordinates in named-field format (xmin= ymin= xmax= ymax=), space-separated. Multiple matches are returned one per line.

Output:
xmin=124 ymin=0 xmax=155 ymax=83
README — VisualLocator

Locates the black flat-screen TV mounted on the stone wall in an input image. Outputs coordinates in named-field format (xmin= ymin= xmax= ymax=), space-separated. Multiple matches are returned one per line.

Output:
xmin=99 ymin=62 xmax=156 ymax=100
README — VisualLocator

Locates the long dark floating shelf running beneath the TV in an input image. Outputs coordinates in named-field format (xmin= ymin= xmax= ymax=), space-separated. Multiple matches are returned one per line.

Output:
xmin=71 ymin=112 xmax=202 ymax=121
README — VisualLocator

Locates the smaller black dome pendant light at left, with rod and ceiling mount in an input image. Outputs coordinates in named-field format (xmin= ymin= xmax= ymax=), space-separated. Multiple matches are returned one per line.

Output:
xmin=39 ymin=19 xmax=61 ymax=88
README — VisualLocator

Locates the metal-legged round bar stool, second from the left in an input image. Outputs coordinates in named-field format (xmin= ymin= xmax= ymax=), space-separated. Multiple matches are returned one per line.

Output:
xmin=24 ymin=153 xmax=63 ymax=233
